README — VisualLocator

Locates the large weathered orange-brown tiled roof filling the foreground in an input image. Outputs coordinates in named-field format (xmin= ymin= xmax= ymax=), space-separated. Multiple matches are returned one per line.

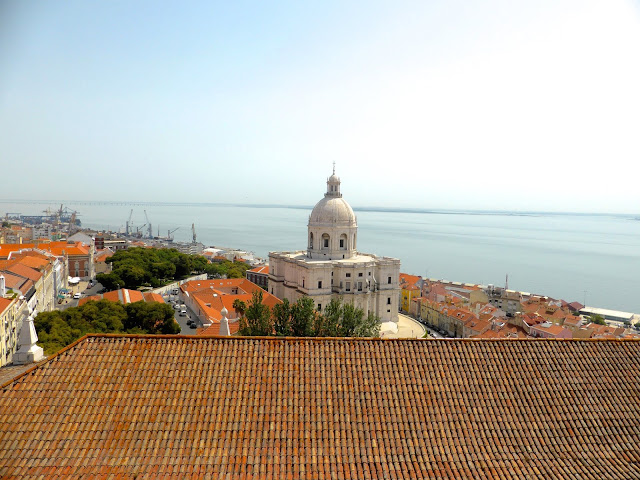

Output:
xmin=0 ymin=335 xmax=640 ymax=479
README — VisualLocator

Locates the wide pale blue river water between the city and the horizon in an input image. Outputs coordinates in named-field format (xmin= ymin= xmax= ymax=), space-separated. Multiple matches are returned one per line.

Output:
xmin=0 ymin=201 xmax=640 ymax=312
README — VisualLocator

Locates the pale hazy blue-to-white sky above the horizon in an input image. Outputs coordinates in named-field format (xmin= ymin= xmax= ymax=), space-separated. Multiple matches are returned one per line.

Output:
xmin=0 ymin=0 xmax=640 ymax=213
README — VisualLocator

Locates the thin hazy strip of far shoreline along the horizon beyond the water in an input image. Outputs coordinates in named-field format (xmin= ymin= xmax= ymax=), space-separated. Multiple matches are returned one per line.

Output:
xmin=0 ymin=200 xmax=640 ymax=221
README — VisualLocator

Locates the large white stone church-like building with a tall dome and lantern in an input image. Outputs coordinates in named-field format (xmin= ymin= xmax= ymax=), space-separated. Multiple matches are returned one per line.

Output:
xmin=269 ymin=167 xmax=400 ymax=322
